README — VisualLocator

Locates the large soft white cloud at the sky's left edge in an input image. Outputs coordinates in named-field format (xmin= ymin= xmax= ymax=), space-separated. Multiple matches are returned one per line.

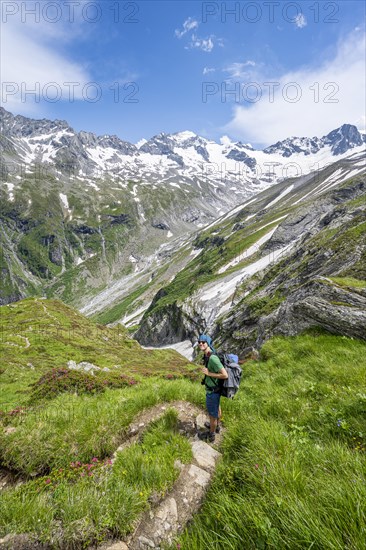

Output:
xmin=0 ymin=2 xmax=92 ymax=114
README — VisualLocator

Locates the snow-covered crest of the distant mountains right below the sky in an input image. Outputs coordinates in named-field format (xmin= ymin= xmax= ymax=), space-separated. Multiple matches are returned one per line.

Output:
xmin=0 ymin=107 xmax=366 ymax=188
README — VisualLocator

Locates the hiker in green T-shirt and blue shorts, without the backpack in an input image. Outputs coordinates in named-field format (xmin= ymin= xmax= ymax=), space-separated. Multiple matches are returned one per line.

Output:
xmin=198 ymin=334 xmax=228 ymax=443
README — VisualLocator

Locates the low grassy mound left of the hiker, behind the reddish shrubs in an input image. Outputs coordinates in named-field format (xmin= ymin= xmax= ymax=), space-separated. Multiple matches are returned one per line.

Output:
xmin=0 ymin=299 xmax=194 ymax=411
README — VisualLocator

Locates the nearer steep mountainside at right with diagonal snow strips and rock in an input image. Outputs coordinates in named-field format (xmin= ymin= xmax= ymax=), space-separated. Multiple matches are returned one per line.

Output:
xmin=136 ymin=155 xmax=366 ymax=354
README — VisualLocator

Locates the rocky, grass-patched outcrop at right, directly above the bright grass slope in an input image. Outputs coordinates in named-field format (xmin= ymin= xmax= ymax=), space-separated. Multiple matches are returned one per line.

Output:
xmin=216 ymin=178 xmax=366 ymax=352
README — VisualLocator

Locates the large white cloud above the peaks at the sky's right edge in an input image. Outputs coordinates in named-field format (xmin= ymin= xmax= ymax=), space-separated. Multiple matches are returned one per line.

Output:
xmin=222 ymin=31 xmax=366 ymax=145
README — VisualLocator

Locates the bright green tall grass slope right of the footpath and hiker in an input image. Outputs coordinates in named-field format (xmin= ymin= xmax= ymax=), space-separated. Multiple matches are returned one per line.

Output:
xmin=172 ymin=334 xmax=366 ymax=550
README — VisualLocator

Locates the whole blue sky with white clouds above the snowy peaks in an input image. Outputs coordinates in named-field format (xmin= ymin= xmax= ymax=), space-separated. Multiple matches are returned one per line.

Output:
xmin=1 ymin=0 xmax=366 ymax=147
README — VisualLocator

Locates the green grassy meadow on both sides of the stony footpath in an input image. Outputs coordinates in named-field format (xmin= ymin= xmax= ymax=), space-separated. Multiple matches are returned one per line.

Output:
xmin=0 ymin=306 xmax=366 ymax=550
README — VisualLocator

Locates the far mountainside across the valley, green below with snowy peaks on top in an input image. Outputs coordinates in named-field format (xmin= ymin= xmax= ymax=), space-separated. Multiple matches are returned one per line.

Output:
xmin=0 ymin=108 xmax=366 ymax=314
